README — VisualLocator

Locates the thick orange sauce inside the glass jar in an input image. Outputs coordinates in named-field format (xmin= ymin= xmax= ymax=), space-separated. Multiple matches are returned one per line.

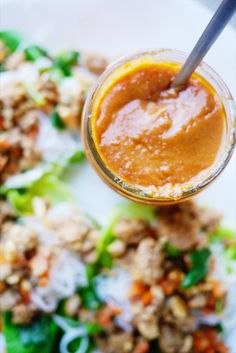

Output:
xmin=92 ymin=63 xmax=226 ymax=192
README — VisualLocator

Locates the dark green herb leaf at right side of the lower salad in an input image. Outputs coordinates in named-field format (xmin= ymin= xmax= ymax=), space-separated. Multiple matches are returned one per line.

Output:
xmin=182 ymin=249 xmax=211 ymax=288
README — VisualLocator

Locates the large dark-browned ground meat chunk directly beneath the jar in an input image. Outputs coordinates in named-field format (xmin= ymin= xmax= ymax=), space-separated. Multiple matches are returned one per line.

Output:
xmin=158 ymin=201 xmax=200 ymax=250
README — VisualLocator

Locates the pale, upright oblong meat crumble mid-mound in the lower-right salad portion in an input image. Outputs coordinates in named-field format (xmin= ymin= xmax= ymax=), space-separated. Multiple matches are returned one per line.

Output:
xmin=133 ymin=238 xmax=164 ymax=285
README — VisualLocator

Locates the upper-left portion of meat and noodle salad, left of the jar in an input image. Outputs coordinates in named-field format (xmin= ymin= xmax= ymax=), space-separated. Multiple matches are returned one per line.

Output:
xmin=0 ymin=31 xmax=107 ymax=183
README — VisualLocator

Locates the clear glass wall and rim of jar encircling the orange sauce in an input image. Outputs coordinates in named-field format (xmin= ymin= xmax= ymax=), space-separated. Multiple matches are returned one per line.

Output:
xmin=81 ymin=49 xmax=236 ymax=205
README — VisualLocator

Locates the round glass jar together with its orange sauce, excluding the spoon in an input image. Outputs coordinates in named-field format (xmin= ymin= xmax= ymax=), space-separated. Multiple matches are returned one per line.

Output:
xmin=82 ymin=49 xmax=236 ymax=205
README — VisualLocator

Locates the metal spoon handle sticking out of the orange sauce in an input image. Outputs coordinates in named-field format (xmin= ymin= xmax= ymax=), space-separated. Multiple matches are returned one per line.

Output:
xmin=170 ymin=0 xmax=236 ymax=88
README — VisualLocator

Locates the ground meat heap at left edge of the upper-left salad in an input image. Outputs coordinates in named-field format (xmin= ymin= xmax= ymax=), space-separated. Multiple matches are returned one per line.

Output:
xmin=0 ymin=81 xmax=41 ymax=183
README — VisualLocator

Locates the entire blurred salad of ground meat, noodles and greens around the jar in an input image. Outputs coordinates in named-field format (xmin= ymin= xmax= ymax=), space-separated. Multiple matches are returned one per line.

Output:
xmin=0 ymin=31 xmax=236 ymax=353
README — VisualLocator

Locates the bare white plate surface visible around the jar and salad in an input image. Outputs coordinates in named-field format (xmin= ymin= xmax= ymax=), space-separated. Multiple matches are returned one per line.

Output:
xmin=0 ymin=0 xmax=236 ymax=225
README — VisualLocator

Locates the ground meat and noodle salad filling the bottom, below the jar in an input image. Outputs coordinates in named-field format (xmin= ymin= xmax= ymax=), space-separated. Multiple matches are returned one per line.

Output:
xmin=0 ymin=197 xmax=236 ymax=353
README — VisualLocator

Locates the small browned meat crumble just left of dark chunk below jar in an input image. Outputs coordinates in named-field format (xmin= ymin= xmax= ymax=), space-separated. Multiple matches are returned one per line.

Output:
xmin=114 ymin=219 xmax=149 ymax=245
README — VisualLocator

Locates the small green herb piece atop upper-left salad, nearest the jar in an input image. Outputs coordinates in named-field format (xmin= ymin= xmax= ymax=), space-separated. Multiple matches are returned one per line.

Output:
xmin=54 ymin=50 xmax=79 ymax=76
